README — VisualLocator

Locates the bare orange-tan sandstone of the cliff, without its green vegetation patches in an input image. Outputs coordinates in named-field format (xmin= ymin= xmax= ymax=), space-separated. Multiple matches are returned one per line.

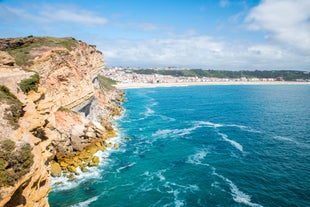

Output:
xmin=0 ymin=38 xmax=125 ymax=206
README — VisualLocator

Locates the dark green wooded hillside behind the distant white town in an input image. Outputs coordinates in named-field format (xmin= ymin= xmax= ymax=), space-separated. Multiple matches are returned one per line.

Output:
xmin=134 ymin=69 xmax=310 ymax=81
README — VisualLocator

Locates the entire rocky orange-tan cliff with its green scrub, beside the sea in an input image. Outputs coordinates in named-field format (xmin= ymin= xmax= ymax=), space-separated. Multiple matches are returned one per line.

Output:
xmin=0 ymin=37 xmax=122 ymax=206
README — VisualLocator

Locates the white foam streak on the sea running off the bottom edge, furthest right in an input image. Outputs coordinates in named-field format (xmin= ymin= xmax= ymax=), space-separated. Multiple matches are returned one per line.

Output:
xmin=212 ymin=168 xmax=263 ymax=207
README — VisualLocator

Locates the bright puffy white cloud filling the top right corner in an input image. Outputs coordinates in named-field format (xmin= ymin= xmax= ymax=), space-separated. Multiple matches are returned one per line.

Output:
xmin=246 ymin=0 xmax=310 ymax=52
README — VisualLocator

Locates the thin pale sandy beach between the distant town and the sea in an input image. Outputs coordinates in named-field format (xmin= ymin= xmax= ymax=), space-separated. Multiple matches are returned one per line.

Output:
xmin=115 ymin=81 xmax=310 ymax=89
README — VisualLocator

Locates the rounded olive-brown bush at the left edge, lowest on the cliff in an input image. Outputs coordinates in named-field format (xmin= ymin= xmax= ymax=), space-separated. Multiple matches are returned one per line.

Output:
xmin=0 ymin=139 xmax=33 ymax=187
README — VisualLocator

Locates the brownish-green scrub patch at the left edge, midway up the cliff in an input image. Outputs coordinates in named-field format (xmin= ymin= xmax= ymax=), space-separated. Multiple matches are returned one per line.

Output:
xmin=0 ymin=85 xmax=24 ymax=128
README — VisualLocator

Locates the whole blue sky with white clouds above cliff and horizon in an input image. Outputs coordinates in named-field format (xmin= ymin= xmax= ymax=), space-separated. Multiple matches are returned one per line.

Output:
xmin=0 ymin=0 xmax=310 ymax=71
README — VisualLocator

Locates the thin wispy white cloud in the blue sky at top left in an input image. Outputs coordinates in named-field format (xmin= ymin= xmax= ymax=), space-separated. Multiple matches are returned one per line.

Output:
xmin=0 ymin=4 xmax=107 ymax=25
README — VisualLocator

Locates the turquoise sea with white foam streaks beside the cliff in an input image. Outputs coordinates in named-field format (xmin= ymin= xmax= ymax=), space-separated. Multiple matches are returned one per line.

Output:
xmin=49 ymin=85 xmax=310 ymax=207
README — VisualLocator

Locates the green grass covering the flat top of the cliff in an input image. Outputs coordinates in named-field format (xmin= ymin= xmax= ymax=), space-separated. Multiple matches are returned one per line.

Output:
xmin=7 ymin=36 xmax=77 ymax=66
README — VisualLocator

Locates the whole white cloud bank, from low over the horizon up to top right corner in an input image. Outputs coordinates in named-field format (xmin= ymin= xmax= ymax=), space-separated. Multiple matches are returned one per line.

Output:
xmin=99 ymin=0 xmax=310 ymax=71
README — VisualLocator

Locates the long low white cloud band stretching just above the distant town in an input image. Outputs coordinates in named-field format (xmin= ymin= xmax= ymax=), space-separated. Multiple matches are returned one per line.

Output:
xmin=98 ymin=36 xmax=310 ymax=70
